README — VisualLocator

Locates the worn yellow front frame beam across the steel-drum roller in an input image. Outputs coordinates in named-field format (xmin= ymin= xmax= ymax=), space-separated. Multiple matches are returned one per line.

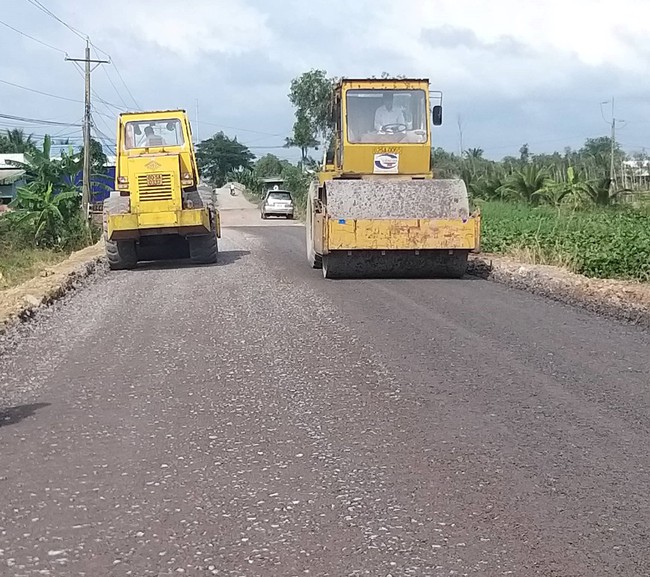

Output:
xmin=327 ymin=216 xmax=480 ymax=251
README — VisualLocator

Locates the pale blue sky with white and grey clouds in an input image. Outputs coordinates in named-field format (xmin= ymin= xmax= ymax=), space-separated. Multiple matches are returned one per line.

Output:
xmin=0 ymin=0 xmax=650 ymax=161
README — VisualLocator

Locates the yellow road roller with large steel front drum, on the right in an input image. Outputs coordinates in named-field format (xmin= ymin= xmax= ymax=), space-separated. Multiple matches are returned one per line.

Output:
xmin=306 ymin=78 xmax=480 ymax=279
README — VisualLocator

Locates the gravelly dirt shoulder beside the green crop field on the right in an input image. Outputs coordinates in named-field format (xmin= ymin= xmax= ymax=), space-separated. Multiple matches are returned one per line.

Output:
xmin=468 ymin=255 xmax=650 ymax=328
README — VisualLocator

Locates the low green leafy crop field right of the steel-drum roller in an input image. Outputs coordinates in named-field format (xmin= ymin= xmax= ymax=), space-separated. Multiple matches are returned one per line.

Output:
xmin=481 ymin=202 xmax=650 ymax=281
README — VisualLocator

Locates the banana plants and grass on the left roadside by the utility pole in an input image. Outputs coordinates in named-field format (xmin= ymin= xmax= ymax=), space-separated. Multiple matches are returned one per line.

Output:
xmin=0 ymin=131 xmax=101 ymax=289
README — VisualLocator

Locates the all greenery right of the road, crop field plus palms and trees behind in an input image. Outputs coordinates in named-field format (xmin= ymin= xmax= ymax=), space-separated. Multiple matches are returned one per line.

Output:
xmin=440 ymin=137 xmax=650 ymax=281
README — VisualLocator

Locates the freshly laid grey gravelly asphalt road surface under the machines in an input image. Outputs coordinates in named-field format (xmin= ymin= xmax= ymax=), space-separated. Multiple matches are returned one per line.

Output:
xmin=0 ymin=187 xmax=650 ymax=577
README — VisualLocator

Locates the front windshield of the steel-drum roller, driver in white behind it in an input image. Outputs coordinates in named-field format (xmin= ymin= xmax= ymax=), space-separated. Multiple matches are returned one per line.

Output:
xmin=346 ymin=90 xmax=427 ymax=144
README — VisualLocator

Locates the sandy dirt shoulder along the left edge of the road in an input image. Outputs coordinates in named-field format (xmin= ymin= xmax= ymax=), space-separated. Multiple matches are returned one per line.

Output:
xmin=0 ymin=240 xmax=104 ymax=334
